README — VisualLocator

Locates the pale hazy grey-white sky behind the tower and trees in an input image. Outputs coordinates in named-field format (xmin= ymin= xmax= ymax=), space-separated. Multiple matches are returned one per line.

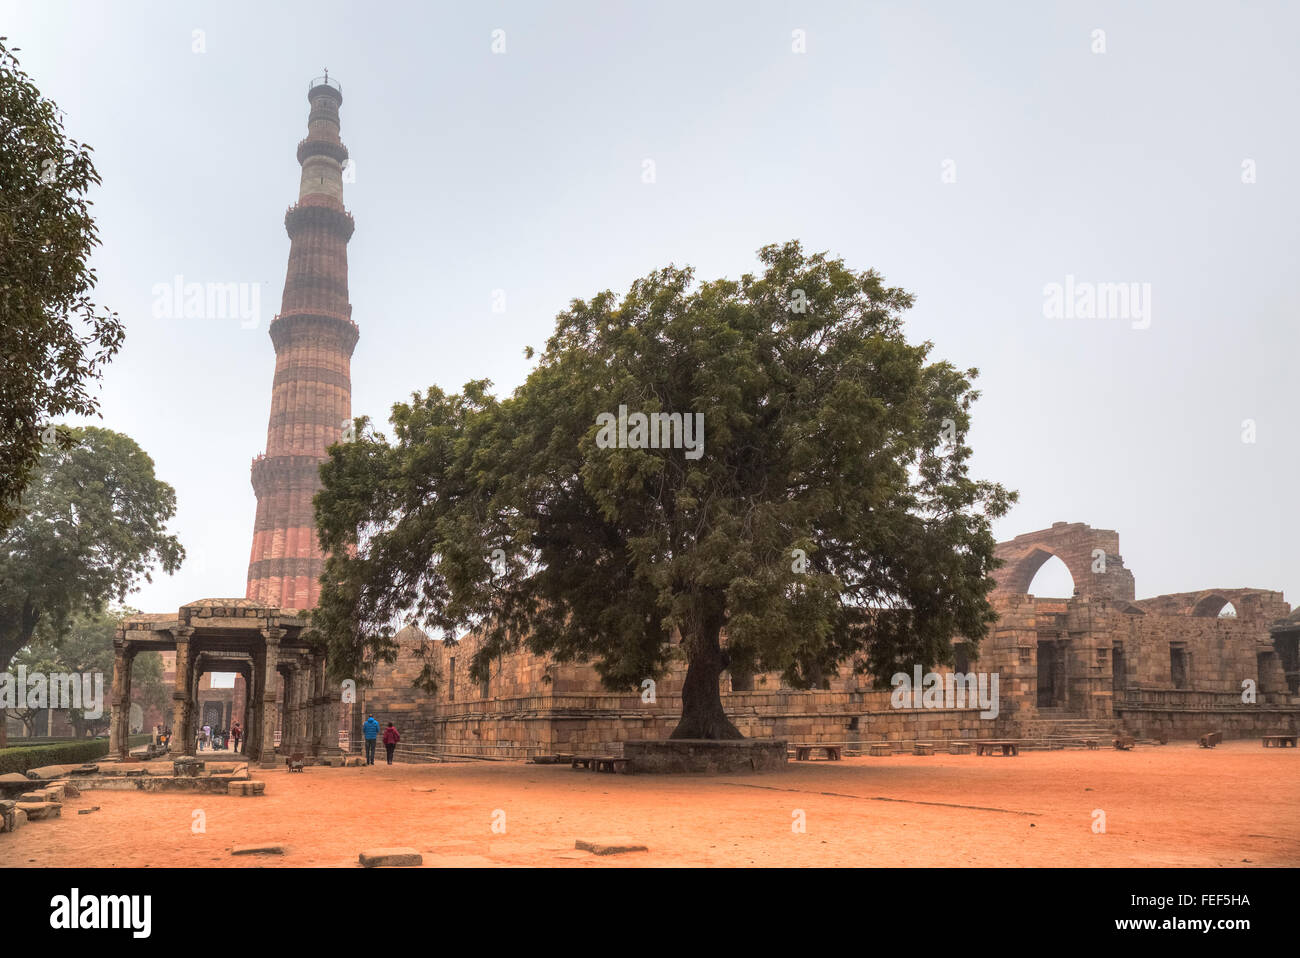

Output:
xmin=0 ymin=0 xmax=1300 ymax=611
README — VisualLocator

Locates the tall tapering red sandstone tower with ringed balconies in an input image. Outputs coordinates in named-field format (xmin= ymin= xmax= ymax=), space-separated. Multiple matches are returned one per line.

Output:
xmin=247 ymin=74 xmax=358 ymax=608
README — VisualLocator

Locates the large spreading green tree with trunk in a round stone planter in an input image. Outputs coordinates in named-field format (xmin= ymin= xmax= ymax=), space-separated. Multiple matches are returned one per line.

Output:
xmin=316 ymin=242 xmax=1014 ymax=738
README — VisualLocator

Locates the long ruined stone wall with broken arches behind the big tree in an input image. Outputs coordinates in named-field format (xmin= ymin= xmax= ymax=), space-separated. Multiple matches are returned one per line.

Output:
xmin=358 ymin=523 xmax=1300 ymax=758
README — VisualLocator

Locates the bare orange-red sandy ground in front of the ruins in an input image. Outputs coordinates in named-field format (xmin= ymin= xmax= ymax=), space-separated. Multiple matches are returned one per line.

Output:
xmin=0 ymin=741 xmax=1300 ymax=867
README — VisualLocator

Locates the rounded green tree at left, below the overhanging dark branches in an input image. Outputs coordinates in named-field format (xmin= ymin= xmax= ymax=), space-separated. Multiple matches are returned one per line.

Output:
xmin=0 ymin=426 xmax=185 ymax=668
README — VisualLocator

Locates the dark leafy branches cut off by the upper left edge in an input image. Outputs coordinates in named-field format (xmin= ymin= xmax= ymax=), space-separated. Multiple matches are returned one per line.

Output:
xmin=0 ymin=36 xmax=124 ymax=529
